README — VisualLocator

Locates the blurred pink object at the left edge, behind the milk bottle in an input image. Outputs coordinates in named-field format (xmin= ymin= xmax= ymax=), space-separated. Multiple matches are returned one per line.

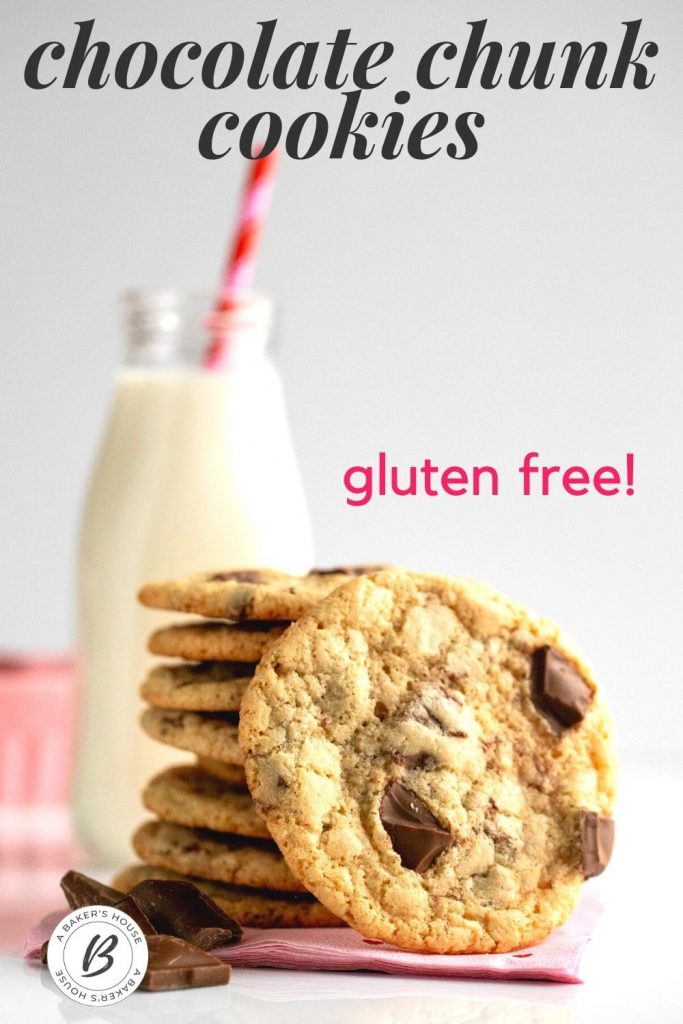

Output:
xmin=0 ymin=654 xmax=75 ymax=808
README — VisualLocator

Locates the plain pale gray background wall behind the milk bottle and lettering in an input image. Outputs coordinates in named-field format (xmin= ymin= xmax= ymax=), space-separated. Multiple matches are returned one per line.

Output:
xmin=0 ymin=0 xmax=683 ymax=748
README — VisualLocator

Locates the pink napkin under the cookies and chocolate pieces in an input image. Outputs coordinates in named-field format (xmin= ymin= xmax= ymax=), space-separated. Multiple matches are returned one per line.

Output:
xmin=24 ymin=891 xmax=601 ymax=984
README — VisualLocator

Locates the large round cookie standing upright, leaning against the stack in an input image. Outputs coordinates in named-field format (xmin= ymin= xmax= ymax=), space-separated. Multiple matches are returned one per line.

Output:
xmin=240 ymin=572 xmax=613 ymax=952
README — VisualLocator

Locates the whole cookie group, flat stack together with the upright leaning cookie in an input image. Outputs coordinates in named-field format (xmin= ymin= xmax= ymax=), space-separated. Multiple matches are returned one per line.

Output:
xmin=117 ymin=570 xmax=614 ymax=953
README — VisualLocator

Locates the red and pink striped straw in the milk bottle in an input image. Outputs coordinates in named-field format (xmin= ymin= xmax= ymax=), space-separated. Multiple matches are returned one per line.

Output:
xmin=204 ymin=150 xmax=279 ymax=370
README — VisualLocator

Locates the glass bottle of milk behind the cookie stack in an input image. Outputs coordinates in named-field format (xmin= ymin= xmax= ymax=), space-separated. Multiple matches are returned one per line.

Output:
xmin=74 ymin=292 xmax=312 ymax=863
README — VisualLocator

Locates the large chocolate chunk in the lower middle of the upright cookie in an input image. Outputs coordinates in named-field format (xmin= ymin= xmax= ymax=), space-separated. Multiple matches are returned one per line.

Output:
xmin=380 ymin=782 xmax=453 ymax=872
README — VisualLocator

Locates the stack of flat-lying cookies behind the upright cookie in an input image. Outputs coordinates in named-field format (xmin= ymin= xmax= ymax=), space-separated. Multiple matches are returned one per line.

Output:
xmin=116 ymin=567 xmax=378 ymax=927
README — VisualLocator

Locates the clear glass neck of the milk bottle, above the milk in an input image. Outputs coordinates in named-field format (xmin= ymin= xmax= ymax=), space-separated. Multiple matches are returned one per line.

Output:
xmin=123 ymin=291 xmax=273 ymax=370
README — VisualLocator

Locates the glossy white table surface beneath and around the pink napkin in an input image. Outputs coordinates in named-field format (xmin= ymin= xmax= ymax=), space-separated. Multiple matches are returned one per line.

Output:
xmin=0 ymin=753 xmax=683 ymax=1024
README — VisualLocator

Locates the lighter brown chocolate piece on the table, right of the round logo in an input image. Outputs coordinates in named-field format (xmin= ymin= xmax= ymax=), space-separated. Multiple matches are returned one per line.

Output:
xmin=140 ymin=935 xmax=230 ymax=992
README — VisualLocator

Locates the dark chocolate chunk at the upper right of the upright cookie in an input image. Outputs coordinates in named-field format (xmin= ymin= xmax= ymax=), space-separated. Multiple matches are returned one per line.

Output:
xmin=531 ymin=647 xmax=593 ymax=732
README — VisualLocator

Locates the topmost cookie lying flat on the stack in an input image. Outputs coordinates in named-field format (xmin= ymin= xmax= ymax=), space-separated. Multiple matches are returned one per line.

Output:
xmin=138 ymin=565 xmax=380 ymax=623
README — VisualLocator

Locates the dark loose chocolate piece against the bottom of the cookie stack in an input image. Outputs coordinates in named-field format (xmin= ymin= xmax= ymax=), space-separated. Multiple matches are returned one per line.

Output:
xmin=130 ymin=879 xmax=242 ymax=949
